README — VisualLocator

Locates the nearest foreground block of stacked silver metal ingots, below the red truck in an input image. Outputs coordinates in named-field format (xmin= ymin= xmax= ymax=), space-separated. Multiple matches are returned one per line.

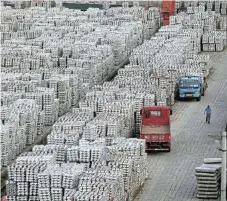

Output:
xmin=7 ymin=138 xmax=147 ymax=200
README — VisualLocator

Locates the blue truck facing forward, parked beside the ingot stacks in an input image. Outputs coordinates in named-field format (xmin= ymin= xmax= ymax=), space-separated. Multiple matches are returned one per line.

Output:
xmin=176 ymin=76 xmax=207 ymax=101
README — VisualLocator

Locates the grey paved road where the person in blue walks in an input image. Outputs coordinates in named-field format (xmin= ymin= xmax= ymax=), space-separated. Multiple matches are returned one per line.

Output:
xmin=135 ymin=48 xmax=227 ymax=201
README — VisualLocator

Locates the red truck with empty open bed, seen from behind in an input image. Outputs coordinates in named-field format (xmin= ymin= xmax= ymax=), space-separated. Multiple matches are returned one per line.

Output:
xmin=139 ymin=106 xmax=171 ymax=152
